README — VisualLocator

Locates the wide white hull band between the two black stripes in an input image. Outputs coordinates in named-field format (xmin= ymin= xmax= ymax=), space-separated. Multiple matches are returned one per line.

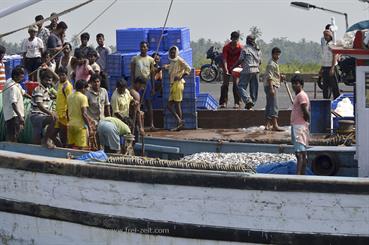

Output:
xmin=0 ymin=169 xmax=369 ymax=236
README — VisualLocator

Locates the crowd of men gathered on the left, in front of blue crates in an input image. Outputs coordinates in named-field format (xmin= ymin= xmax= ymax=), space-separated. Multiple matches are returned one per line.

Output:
xmin=0 ymin=13 xmax=191 ymax=153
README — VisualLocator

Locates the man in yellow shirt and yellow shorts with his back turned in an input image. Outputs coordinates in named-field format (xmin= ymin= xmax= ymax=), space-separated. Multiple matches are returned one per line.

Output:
xmin=67 ymin=80 xmax=92 ymax=149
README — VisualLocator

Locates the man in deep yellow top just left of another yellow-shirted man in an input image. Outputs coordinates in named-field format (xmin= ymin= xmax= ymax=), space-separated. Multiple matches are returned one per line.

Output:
xmin=55 ymin=66 xmax=73 ymax=147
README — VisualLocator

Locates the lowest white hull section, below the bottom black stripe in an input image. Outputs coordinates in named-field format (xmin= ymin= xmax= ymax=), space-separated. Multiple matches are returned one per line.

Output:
xmin=0 ymin=212 xmax=249 ymax=245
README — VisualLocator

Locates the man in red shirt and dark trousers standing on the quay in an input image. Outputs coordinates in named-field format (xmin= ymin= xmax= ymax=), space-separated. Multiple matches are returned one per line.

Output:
xmin=219 ymin=31 xmax=242 ymax=108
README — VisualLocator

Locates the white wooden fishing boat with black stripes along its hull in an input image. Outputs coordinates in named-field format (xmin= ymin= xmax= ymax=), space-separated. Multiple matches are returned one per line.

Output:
xmin=0 ymin=0 xmax=369 ymax=245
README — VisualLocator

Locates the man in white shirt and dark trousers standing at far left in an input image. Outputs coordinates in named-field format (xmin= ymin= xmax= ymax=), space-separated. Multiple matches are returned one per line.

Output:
xmin=3 ymin=66 xmax=24 ymax=142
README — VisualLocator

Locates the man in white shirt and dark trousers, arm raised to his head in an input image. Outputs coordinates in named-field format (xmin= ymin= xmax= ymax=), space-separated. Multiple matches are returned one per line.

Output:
xmin=319 ymin=30 xmax=340 ymax=99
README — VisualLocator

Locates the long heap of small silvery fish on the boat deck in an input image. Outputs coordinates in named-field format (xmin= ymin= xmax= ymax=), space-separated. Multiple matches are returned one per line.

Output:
xmin=108 ymin=152 xmax=296 ymax=173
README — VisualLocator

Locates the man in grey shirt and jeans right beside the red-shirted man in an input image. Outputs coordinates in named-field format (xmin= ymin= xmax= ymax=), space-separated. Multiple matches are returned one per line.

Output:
xmin=234 ymin=35 xmax=261 ymax=110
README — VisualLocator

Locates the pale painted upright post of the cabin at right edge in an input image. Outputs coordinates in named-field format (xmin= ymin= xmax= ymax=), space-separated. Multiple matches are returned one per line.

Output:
xmin=355 ymin=66 xmax=369 ymax=177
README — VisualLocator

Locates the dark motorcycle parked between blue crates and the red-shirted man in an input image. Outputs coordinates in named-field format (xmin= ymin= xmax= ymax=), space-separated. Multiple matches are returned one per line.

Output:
xmin=200 ymin=46 xmax=223 ymax=82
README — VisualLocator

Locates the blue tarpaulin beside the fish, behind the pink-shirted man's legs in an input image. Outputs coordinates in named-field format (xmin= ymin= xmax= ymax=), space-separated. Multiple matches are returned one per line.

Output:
xmin=256 ymin=161 xmax=314 ymax=175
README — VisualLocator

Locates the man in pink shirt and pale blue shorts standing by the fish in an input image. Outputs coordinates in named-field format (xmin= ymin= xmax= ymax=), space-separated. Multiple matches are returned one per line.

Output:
xmin=291 ymin=75 xmax=310 ymax=175
